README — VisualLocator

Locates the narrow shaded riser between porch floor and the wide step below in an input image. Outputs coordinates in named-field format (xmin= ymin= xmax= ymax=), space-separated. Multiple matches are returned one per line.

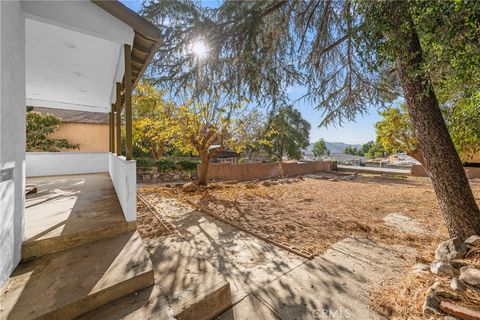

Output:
xmin=22 ymin=221 xmax=136 ymax=261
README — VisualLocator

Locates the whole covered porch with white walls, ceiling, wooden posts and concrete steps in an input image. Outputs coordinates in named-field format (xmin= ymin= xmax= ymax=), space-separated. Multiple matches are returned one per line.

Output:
xmin=0 ymin=0 xmax=160 ymax=319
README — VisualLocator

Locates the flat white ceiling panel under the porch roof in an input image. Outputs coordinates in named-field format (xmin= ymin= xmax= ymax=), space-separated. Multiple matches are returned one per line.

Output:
xmin=26 ymin=18 xmax=123 ymax=112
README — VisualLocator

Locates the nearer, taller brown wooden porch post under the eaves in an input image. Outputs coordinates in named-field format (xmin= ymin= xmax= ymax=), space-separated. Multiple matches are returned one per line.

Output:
xmin=124 ymin=44 xmax=132 ymax=160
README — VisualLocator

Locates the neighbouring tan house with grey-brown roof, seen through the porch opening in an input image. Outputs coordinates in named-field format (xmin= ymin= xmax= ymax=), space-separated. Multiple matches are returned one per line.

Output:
xmin=32 ymin=107 xmax=109 ymax=152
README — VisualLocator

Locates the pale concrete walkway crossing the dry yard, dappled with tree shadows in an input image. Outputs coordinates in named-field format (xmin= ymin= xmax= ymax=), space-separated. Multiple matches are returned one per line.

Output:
xmin=150 ymin=199 xmax=414 ymax=320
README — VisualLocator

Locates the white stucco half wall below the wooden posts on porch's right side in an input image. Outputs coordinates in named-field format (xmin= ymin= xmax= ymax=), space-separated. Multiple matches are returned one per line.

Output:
xmin=109 ymin=153 xmax=137 ymax=221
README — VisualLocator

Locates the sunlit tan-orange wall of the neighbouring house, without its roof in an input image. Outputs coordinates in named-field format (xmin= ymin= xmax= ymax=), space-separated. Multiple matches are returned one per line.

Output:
xmin=49 ymin=122 xmax=109 ymax=152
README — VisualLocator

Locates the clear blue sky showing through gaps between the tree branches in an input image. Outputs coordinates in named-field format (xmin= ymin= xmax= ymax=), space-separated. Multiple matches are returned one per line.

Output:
xmin=121 ymin=0 xmax=381 ymax=144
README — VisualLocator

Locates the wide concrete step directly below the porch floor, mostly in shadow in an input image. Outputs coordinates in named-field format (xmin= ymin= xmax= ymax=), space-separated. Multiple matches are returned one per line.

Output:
xmin=0 ymin=232 xmax=154 ymax=320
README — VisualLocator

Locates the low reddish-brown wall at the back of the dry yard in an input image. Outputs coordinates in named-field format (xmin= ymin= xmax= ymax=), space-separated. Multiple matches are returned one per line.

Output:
xmin=202 ymin=161 xmax=336 ymax=181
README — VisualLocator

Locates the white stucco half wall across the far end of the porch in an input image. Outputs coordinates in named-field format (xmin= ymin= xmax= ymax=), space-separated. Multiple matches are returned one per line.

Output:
xmin=26 ymin=152 xmax=108 ymax=177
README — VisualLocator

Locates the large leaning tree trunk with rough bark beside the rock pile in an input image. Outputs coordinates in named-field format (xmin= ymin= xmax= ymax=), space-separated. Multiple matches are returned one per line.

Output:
xmin=394 ymin=10 xmax=480 ymax=239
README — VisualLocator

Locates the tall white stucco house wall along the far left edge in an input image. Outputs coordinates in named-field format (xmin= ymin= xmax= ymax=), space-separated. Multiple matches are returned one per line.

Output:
xmin=0 ymin=1 xmax=25 ymax=288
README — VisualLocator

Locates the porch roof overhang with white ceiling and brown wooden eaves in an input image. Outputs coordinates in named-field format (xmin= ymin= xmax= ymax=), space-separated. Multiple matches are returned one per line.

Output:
xmin=22 ymin=0 xmax=161 ymax=112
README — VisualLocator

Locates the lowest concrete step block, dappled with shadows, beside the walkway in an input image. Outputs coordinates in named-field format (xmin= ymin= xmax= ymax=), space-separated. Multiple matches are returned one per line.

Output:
xmin=148 ymin=235 xmax=232 ymax=320
